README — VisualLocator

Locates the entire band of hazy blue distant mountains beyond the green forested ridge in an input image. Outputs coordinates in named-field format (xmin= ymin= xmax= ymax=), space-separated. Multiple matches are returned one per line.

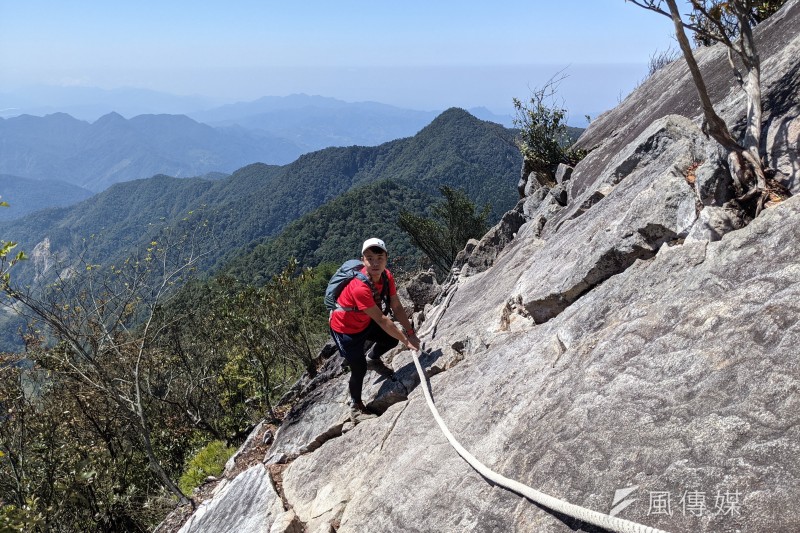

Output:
xmin=0 ymin=95 xmax=520 ymax=192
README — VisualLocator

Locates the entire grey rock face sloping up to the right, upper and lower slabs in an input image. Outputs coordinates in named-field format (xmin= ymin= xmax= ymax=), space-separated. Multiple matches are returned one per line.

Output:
xmin=177 ymin=0 xmax=800 ymax=533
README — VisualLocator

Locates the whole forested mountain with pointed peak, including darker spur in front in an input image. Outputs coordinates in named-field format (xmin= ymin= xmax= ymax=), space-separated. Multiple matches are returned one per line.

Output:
xmin=0 ymin=109 xmax=521 ymax=347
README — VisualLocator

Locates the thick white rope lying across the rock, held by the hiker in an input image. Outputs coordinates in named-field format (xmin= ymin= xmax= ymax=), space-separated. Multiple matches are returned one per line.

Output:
xmin=411 ymin=350 xmax=666 ymax=533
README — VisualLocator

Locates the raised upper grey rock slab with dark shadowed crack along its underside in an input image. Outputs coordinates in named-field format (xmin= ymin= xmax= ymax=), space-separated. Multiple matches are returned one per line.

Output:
xmin=515 ymin=115 xmax=706 ymax=323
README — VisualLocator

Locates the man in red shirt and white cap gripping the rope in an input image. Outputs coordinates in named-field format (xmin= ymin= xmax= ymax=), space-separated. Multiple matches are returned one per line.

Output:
xmin=330 ymin=238 xmax=419 ymax=423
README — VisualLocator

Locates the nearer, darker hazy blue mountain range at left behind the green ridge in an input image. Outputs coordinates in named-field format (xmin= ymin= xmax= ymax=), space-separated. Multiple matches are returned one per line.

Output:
xmin=0 ymin=113 xmax=304 ymax=192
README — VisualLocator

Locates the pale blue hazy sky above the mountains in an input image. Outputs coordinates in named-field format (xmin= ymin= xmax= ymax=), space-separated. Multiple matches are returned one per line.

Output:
xmin=0 ymin=0 xmax=676 ymax=117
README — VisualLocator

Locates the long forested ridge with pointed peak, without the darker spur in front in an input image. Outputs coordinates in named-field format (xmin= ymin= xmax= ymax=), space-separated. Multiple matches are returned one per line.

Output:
xmin=0 ymin=109 xmax=521 ymax=276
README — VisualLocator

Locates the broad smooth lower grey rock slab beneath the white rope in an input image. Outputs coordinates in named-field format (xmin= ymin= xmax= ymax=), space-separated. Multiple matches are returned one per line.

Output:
xmin=284 ymin=196 xmax=800 ymax=532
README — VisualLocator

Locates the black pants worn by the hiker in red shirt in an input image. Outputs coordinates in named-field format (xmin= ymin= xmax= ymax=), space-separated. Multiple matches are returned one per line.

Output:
xmin=331 ymin=320 xmax=399 ymax=402
